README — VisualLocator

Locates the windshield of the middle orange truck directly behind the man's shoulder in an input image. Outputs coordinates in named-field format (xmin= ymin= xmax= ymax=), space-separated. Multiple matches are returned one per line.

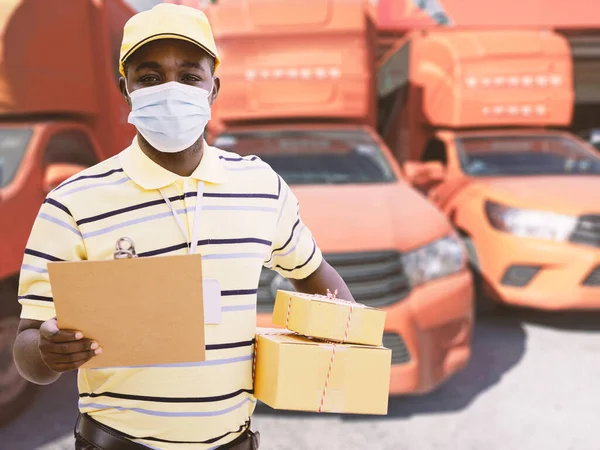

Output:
xmin=214 ymin=130 xmax=395 ymax=185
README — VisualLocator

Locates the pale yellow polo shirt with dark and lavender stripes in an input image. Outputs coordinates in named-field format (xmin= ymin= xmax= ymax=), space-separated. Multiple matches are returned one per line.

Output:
xmin=19 ymin=140 xmax=322 ymax=450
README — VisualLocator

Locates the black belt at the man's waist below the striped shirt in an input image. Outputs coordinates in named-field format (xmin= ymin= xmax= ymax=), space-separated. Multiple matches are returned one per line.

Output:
xmin=75 ymin=414 xmax=260 ymax=450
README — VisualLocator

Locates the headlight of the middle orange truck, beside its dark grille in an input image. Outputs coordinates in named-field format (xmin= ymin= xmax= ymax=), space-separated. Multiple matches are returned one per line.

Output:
xmin=402 ymin=235 xmax=466 ymax=287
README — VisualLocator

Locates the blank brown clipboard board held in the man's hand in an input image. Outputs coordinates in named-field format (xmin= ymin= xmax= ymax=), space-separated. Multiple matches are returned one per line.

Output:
xmin=48 ymin=255 xmax=206 ymax=369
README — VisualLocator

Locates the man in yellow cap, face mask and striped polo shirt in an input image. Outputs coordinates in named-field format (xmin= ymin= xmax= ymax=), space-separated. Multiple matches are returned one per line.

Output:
xmin=15 ymin=4 xmax=352 ymax=450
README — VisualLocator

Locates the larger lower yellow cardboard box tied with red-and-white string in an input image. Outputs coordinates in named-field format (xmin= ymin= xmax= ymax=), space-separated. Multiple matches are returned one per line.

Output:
xmin=254 ymin=328 xmax=392 ymax=415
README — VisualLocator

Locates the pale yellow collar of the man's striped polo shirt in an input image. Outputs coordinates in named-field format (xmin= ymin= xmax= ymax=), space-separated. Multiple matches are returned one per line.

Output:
xmin=119 ymin=136 xmax=227 ymax=190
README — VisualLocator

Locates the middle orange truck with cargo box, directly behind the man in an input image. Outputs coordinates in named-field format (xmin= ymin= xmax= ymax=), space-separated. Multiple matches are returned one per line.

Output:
xmin=166 ymin=0 xmax=473 ymax=394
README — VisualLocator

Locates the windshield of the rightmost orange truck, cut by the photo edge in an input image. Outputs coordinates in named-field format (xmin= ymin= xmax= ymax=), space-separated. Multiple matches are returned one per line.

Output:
xmin=457 ymin=136 xmax=600 ymax=176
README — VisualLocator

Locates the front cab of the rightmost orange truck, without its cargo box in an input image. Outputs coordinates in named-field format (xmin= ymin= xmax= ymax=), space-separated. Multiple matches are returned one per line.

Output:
xmin=412 ymin=129 xmax=600 ymax=310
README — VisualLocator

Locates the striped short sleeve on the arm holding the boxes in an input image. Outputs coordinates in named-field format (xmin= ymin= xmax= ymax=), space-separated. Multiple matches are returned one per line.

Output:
xmin=265 ymin=176 xmax=323 ymax=279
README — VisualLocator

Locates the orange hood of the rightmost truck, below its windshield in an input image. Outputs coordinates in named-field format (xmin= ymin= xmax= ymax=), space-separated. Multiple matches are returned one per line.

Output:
xmin=479 ymin=175 xmax=600 ymax=215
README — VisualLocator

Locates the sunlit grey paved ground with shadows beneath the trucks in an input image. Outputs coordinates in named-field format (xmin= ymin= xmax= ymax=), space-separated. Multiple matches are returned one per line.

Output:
xmin=0 ymin=312 xmax=600 ymax=450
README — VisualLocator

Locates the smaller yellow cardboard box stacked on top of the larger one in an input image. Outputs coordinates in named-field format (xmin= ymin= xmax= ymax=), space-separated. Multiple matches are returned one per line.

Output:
xmin=272 ymin=290 xmax=385 ymax=346
